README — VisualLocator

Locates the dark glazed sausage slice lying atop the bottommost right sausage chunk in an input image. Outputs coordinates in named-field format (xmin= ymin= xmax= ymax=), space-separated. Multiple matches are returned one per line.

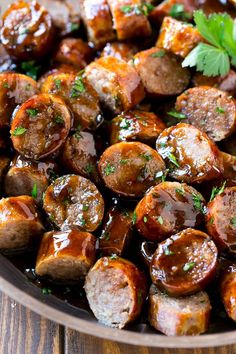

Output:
xmin=150 ymin=228 xmax=218 ymax=296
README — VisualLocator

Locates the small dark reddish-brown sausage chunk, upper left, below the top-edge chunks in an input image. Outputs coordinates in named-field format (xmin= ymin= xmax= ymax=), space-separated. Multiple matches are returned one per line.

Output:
xmin=53 ymin=38 xmax=94 ymax=70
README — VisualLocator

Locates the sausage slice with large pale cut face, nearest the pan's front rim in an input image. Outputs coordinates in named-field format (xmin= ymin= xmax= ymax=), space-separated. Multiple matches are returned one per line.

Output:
xmin=84 ymin=256 xmax=147 ymax=328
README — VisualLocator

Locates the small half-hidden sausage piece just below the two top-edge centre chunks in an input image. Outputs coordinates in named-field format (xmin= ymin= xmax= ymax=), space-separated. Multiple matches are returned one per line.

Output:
xmin=101 ymin=42 xmax=138 ymax=62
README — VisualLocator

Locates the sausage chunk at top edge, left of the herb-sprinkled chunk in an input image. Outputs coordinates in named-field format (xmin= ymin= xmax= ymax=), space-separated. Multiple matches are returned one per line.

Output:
xmin=79 ymin=0 xmax=116 ymax=49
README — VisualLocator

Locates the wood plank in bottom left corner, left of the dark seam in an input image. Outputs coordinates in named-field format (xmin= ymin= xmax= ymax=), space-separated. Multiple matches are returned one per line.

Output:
xmin=0 ymin=293 xmax=64 ymax=354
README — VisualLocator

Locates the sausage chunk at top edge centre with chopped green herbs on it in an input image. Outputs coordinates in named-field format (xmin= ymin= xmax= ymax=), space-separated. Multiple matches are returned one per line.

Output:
xmin=108 ymin=0 xmax=152 ymax=41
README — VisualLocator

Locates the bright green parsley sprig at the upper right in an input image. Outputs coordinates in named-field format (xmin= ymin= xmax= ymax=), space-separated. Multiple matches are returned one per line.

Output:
xmin=182 ymin=10 xmax=236 ymax=76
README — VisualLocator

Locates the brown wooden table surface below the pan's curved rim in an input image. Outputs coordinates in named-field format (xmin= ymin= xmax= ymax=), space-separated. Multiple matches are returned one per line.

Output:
xmin=0 ymin=293 xmax=236 ymax=354
